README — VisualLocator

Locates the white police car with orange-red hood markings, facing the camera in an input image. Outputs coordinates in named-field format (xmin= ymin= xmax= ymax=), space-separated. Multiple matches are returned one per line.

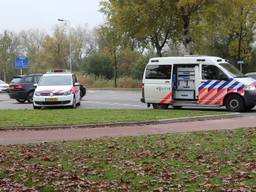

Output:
xmin=33 ymin=70 xmax=81 ymax=109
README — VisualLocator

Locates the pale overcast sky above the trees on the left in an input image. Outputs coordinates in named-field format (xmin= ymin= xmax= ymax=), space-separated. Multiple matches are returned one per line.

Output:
xmin=0 ymin=0 xmax=104 ymax=33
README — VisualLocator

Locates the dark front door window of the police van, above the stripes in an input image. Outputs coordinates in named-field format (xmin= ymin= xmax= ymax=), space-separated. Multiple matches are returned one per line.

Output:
xmin=202 ymin=65 xmax=228 ymax=80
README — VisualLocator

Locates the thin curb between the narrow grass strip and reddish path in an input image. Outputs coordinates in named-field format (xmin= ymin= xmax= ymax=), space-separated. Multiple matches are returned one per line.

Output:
xmin=0 ymin=113 xmax=243 ymax=131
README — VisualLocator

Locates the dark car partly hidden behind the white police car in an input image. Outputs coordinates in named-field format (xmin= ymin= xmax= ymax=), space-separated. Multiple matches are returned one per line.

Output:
xmin=8 ymin=74 xmax=42 ymax=103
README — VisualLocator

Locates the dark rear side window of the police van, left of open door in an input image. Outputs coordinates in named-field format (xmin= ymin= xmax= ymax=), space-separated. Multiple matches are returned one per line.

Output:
xmin=146 ymin=65 xmax=172 ymax=79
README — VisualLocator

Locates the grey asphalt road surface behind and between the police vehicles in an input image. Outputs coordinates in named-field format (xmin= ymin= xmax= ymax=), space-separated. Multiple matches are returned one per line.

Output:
xmin=0 ymin=90 xmax=147 ymax=109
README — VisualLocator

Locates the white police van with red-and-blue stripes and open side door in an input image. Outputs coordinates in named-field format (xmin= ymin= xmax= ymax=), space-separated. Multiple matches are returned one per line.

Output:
xmin=141 ymin=56 xmax=256 ymax=112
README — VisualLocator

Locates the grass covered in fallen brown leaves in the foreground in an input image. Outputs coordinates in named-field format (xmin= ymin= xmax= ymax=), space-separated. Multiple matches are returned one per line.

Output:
xmin=0 ymin=128 xmax=256 ymax=192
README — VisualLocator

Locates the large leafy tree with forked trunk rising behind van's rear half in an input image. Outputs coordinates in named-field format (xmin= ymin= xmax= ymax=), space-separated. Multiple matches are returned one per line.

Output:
xmin=101 ymin=0 xmax=179 ymax=56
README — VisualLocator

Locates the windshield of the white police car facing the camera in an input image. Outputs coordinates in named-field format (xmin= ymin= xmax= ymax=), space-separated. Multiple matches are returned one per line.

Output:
xmin=38 ymin=75 xmax=72 ymax=86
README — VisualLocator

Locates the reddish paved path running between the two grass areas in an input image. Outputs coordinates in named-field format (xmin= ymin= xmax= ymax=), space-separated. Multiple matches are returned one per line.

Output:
xmin=0 ymin=116 xmax=256 ymax=145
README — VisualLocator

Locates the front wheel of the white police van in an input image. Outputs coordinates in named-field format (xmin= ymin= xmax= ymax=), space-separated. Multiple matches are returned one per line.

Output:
xmin=225 ymin=95 xmax=245 ymax=112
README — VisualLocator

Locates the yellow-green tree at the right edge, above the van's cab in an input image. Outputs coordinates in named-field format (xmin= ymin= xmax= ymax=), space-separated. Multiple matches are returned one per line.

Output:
xmin=194 ymin=0 xmax=256 ymax=69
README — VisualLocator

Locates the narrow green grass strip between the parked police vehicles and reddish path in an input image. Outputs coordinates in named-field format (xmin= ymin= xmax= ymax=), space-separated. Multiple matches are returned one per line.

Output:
xmin=0 ymin=109 xmax=228 ymax=129
